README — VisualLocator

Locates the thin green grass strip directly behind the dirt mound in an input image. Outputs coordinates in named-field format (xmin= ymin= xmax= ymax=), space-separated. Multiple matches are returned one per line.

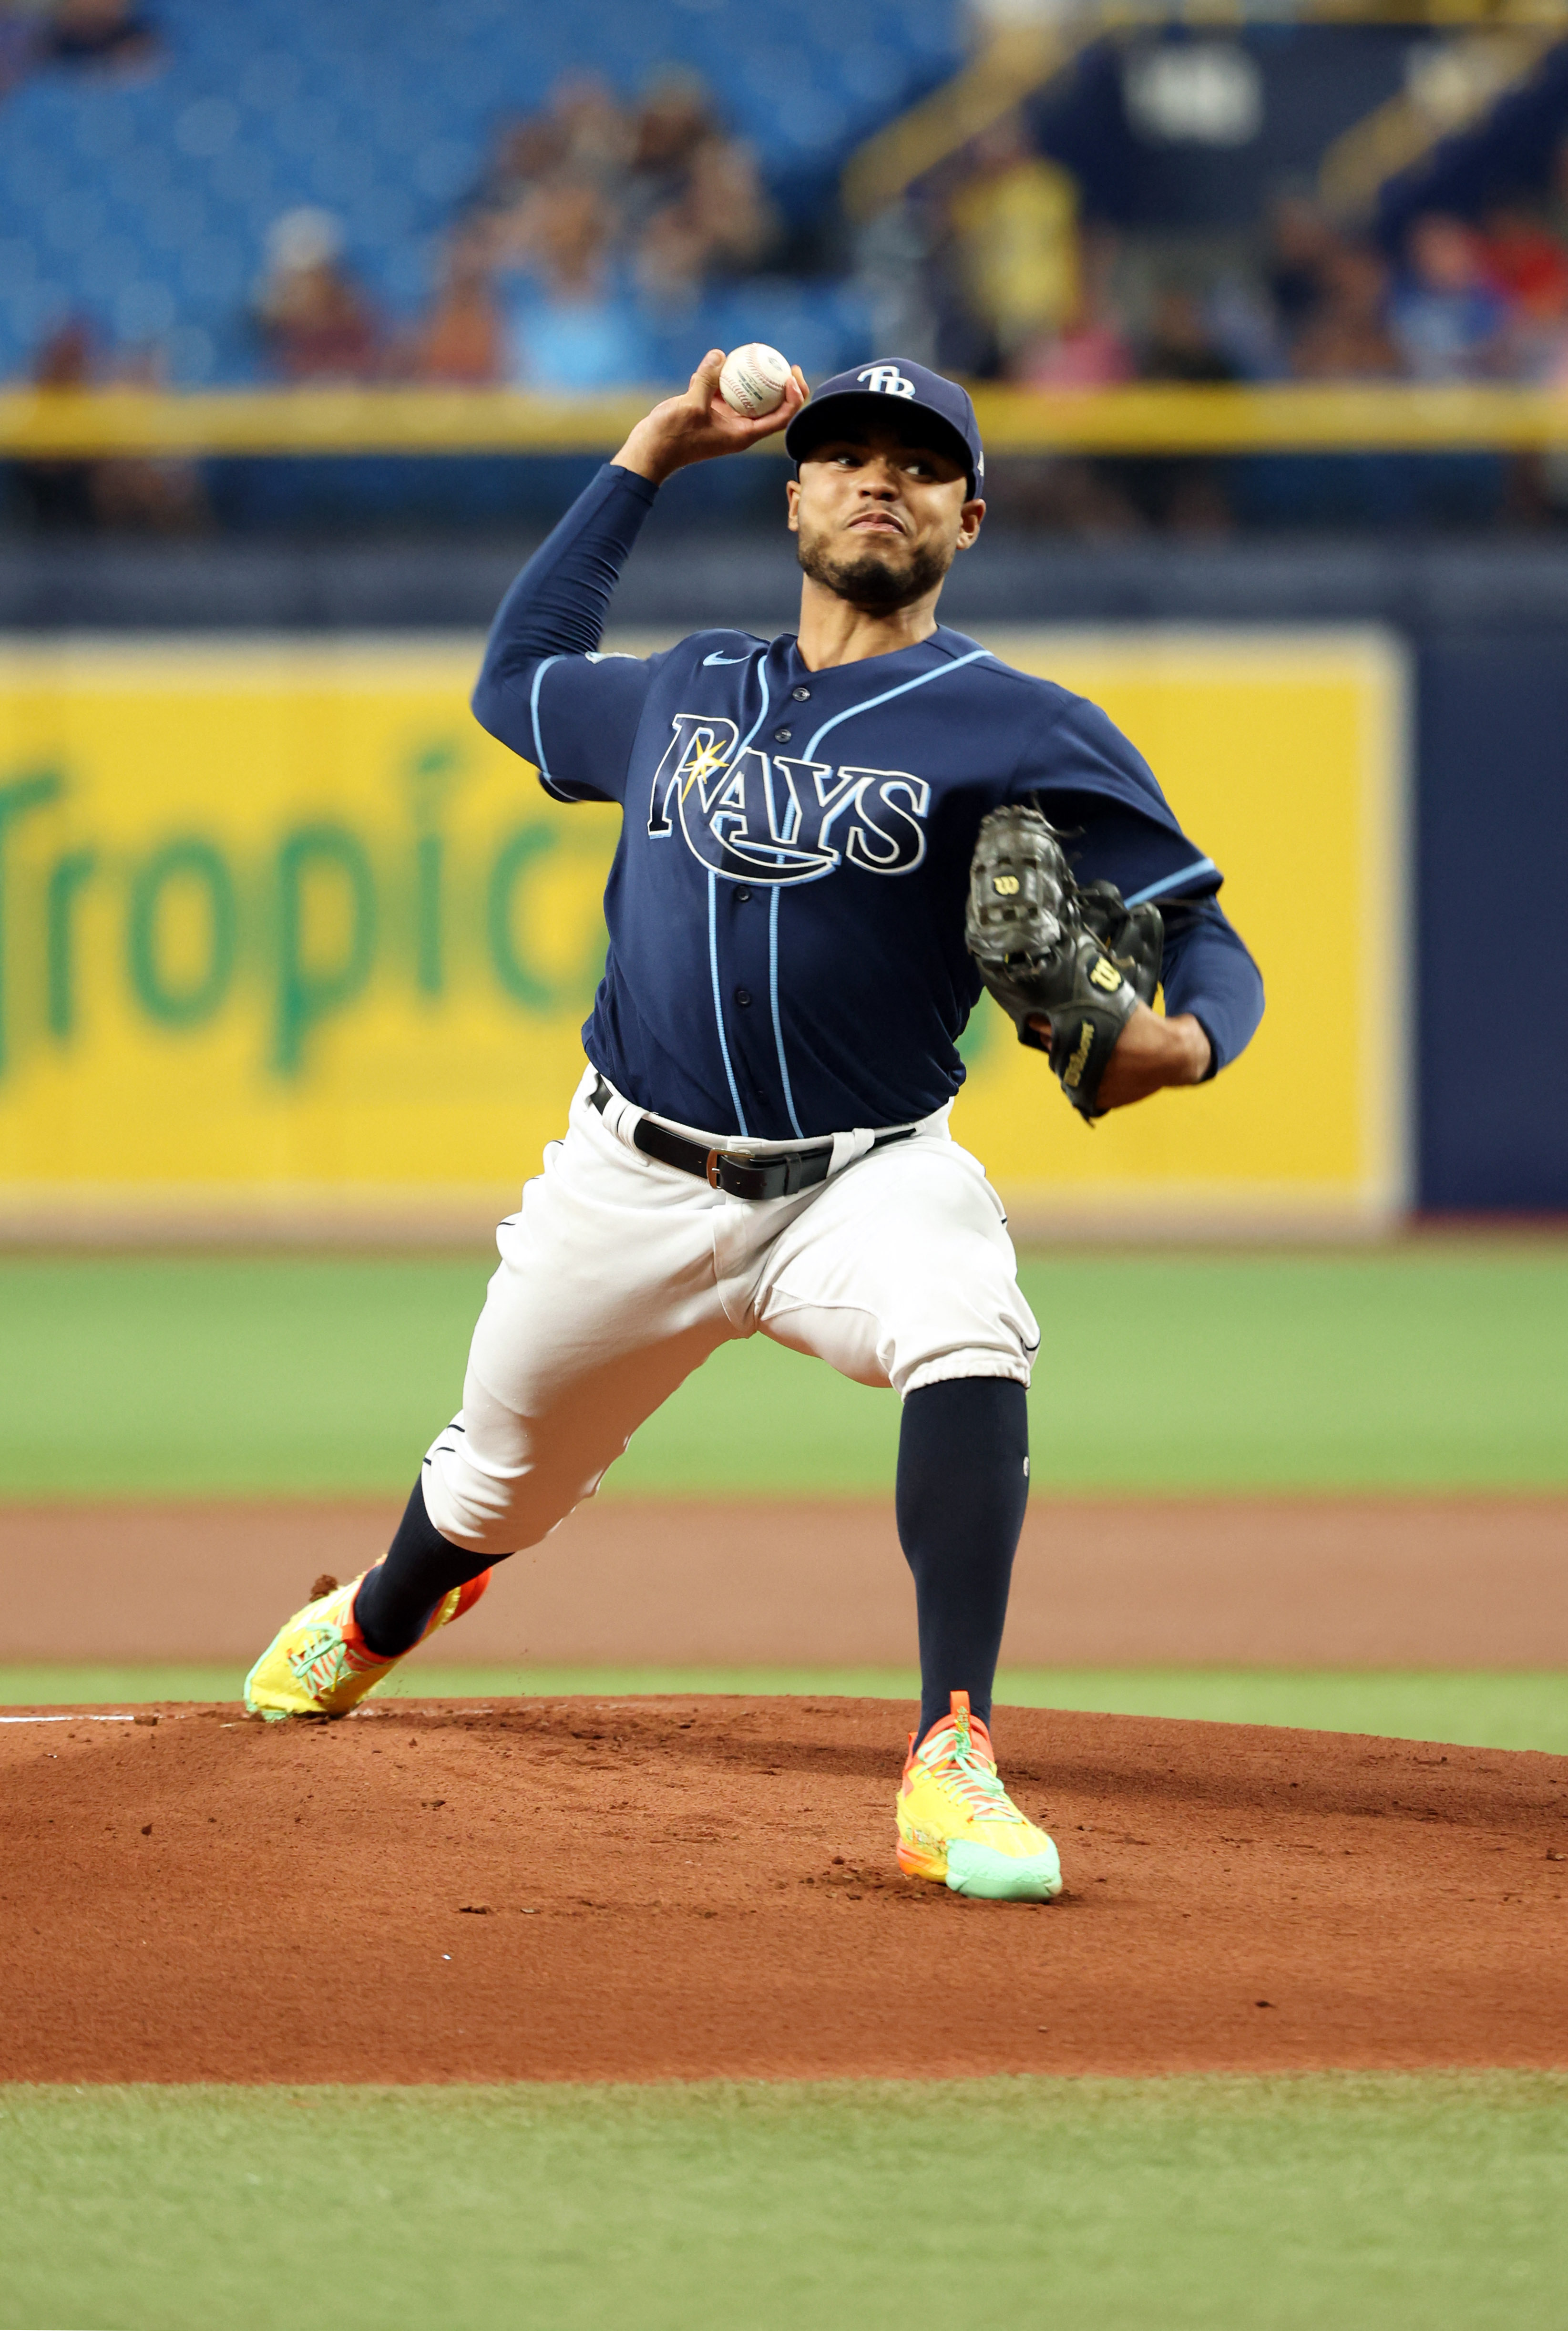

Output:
xmin=0 ymin=1660 xmax=1568 ymax=1755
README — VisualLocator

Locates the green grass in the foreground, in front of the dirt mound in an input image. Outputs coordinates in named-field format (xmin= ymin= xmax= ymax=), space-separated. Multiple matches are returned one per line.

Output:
xmin=0 ymin=2072 xmax=1568 ymax=2331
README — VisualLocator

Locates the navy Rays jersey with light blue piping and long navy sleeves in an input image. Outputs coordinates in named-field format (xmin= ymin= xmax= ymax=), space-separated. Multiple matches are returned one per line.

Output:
xmin=473 ymin=466 xmax=1263 ymax=1140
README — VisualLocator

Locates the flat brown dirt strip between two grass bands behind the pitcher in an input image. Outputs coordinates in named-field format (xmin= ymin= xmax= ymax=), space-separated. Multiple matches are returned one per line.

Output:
xmin=0 ymin=1497 xmax=1568 ymax=1681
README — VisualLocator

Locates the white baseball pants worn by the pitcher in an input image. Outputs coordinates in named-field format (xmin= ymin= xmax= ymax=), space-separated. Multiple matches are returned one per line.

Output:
xmin=424 ymin=1070 xmax=1039 ymax=1555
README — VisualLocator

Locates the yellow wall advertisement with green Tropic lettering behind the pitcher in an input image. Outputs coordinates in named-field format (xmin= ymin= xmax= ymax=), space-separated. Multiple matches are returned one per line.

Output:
xmin=0 ymin=625 xmax=1410 ymax=1235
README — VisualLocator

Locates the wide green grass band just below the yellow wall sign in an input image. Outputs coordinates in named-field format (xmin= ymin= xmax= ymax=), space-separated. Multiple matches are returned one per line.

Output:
xmin=0 ymin=1243 xmax=1568 ymax=1499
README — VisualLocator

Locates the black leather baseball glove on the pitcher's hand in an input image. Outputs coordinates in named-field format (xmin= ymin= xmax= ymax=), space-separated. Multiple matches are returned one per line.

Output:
xmin=964 ymin=804 xmax=1165 ymax=1123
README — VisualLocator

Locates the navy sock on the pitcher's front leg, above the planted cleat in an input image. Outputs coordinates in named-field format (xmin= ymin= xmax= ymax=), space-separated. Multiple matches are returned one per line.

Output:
xmin=897 ymin=1376 xmax=1030 ymax=1739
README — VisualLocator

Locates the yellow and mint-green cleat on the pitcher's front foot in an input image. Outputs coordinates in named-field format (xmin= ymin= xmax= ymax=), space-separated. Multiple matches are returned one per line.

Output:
xmin=899 ymin=1692 xmax=1063 ymax=1902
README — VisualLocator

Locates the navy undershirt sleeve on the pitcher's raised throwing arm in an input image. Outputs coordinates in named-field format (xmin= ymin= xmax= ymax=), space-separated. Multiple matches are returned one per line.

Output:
xmin=473 ymin=464 xmax=657 ymax=718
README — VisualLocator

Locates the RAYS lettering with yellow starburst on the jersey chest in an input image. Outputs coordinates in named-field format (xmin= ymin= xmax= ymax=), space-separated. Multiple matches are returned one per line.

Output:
xmin=648 ymin=713 xmax=932 ymax=886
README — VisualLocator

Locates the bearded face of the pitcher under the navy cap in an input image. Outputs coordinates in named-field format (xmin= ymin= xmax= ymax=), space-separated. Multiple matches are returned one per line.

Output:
xmin=788 ymin=427 xmax=985 ymax=608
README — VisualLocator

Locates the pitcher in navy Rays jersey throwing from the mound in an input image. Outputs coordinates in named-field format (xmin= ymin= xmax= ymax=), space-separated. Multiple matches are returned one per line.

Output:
xmin=245 ymin=349 xmax=1263 ymax=1902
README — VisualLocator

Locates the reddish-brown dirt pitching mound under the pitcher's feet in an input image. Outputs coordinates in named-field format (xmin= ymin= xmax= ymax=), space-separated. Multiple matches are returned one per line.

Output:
xmin=0 ymin=1699 xmax=1568 ymax=2082
